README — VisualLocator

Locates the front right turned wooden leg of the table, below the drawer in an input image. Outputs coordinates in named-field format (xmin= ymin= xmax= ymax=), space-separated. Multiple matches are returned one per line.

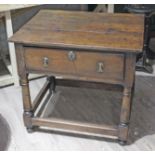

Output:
xmin=118 ymin=88 xmax=133 ymax=145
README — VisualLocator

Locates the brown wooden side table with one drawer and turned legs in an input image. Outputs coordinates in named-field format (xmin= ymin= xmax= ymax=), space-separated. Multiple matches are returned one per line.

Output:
xmin=9 ymin=10 xmax=144 ymax=144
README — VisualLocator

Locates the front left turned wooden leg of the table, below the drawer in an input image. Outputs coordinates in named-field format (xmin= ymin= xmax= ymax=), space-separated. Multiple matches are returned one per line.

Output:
xmin=21 ymin=74 xmax=33 ymax=132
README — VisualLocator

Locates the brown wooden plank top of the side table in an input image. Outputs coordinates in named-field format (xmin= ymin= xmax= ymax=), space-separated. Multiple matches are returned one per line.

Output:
xmin=9 ymin=10 xmax=144 ymax=52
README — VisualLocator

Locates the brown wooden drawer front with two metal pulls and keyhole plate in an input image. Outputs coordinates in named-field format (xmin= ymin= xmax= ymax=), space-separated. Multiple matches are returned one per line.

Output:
xmin=25 ymin=48 xmax=124 ymax=80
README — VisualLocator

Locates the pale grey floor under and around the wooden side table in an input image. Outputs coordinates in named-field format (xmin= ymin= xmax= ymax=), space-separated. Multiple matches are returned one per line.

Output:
xmin=0 ymin=76 xmax=155 ymax=150
